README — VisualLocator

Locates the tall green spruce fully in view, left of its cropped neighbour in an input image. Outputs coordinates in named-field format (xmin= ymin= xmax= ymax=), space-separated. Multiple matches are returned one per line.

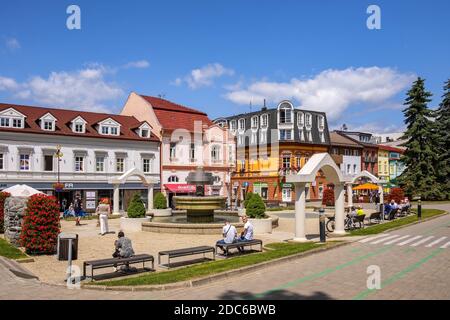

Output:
xmin=398 ymin=77 xmax=440 ymax=200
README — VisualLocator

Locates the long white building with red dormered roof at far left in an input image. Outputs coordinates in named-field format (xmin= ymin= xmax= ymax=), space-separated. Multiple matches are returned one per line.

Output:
xmin=0 ymin=104 xmax=160 ymax=211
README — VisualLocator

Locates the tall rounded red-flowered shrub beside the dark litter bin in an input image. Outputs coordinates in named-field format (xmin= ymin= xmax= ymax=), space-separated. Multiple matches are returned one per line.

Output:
xmin=20 ymin=194 xmax=60 ymax=254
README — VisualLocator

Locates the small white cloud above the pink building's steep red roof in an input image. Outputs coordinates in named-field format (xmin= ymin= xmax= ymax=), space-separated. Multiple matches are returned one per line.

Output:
xmin=173 ymin=63 xmax=234 ymax=89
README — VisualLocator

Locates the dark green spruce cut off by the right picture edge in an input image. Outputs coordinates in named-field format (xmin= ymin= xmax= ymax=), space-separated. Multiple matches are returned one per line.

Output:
xmin=435 ymin=79 xmax=450 ymax=199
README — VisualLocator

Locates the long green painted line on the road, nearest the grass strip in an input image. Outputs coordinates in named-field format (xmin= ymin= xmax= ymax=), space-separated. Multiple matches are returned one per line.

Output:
xmin=250 ymin=245 xmax=392 ymax=300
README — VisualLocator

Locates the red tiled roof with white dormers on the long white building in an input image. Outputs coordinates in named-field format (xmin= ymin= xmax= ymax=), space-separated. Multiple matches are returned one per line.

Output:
xmin=0 ymin=103 xmax=159 ymax=141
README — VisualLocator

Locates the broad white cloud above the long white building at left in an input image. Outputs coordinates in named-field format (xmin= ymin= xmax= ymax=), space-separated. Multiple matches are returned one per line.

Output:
xmin=0 ymin=67 xmax=124 ymax=112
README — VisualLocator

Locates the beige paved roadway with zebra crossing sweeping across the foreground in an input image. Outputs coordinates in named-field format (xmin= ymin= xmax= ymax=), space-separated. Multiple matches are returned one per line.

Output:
xmin=0 ymin=205 xmax=450 ymax=300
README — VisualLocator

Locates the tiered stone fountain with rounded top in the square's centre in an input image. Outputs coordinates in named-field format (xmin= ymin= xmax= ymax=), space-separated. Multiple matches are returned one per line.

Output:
xmin=173 ymin=167 xmax=226 ymax=223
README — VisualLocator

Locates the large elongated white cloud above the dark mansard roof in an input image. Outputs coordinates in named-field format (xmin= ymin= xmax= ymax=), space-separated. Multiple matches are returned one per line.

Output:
xmin=225 ymin=67 xmax=415 ymax=120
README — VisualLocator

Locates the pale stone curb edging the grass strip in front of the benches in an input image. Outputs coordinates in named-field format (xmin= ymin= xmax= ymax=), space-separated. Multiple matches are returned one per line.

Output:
xmin=82 ymin=241 xmax=353 ymax=292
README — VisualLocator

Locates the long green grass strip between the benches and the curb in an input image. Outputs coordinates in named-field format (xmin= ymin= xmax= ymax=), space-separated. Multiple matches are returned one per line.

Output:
xmin=94 ymin=242 xmax=337 ymax=286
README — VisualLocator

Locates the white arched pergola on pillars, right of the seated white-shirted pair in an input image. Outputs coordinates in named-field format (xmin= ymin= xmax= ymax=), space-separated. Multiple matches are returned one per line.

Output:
xmin=286 ymin=153 xmax=383 ymax=241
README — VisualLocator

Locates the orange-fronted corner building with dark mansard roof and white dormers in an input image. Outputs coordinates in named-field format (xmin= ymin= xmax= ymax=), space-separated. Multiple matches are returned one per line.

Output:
xmin=215 ymin=101 xmax=330 ymax=206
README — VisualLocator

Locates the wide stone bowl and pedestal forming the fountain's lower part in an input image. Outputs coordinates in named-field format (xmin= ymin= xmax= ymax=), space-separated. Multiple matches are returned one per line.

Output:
xmin=173 ymin=196 xmax=227 ymax=223
